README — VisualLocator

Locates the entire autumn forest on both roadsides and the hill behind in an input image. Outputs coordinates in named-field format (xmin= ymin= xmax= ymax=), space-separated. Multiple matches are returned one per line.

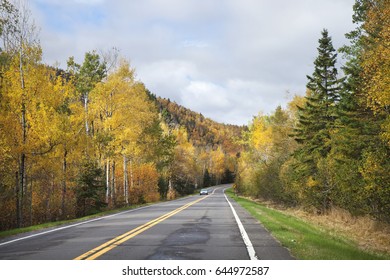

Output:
xmin=0 ymin=0 xmax=390 ymax=230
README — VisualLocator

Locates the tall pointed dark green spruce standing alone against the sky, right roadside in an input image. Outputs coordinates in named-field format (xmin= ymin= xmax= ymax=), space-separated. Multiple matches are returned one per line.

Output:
xmin=294 ymin=29 xmax=345 ymax=211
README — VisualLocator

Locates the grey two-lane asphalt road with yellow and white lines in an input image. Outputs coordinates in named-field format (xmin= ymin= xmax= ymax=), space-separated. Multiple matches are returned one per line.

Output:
xmin=0 ymin=186 xmax=292 ymax=260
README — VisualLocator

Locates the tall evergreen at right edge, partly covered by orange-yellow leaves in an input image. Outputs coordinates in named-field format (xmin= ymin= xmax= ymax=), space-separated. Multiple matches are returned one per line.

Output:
xmin=332 ymin=0 xmax=390 ymax=221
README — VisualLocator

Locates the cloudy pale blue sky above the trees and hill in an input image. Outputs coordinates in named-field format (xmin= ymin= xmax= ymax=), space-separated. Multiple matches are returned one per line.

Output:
xmin=30 ymin=0 xmax=354 ymax=125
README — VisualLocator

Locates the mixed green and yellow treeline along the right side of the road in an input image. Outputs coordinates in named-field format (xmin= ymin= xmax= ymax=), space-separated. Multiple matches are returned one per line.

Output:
xmin=236 ymin=0 xmax=390 ymax=222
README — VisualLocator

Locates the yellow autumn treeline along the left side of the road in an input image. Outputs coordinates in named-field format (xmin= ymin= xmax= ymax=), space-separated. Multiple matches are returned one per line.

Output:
xmin=0 ymin=0 xmax=239 ymax=230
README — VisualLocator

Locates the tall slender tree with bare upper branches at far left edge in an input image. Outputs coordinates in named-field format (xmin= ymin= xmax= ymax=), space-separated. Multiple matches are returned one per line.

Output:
xmin=0 ymin=1 xmax=46 ymax=227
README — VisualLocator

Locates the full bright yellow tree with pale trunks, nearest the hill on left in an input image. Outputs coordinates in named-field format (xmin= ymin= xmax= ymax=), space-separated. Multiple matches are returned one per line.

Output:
xmin=89 ymin=60 xmax=161 ymax=206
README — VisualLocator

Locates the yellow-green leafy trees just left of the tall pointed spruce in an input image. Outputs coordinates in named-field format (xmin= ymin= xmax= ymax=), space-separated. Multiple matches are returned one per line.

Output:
xmin=236 ymin=106 xmax=296 ymax=205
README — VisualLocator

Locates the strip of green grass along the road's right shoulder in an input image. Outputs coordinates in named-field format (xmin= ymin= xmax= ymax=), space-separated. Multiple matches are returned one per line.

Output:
xmin=226 ymin=189 xmax=390 ymax=260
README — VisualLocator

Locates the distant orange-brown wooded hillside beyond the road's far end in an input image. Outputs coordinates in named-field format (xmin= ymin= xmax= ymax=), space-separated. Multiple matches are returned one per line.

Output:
xmin=154 ymin=97 xmax=247 ymax=193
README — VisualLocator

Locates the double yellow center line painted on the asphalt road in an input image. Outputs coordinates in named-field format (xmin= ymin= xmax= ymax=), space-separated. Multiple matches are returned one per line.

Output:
xmin=75 ymin=196 xmax=208 ymax=260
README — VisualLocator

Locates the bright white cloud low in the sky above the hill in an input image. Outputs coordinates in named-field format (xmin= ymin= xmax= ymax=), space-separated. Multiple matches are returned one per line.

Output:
xmin=179 ymin=79 xmax=286 ymax=125
